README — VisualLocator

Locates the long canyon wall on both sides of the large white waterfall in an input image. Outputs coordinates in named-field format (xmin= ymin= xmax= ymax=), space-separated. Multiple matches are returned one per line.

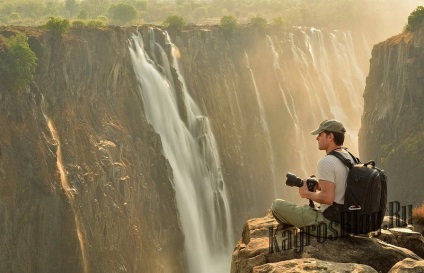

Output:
xmin=0 ymin=26 xmax=368 ymax=273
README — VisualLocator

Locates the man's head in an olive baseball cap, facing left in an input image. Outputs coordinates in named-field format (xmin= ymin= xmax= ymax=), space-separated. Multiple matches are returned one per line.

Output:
xmin=311 ymin=119 xmax=346 ymax=150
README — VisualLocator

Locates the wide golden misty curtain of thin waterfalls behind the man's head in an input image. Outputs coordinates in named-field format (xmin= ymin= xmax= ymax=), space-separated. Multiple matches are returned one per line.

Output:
xmin=267 ymin=28 xmax=365 ymax=176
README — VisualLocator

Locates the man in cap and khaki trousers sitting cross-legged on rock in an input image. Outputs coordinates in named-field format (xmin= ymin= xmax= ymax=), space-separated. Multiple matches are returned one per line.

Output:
xmin=271 ymin=119 xmax=354 ymax=236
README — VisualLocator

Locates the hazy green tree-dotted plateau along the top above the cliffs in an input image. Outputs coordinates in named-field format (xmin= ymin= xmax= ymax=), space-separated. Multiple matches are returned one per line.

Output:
xmin=0 ymin=0 xmax=422 ymax=41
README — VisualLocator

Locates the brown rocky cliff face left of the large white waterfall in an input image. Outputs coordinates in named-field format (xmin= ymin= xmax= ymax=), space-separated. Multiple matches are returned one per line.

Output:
xmin=0 ymin=26 xmax=185 ymax=272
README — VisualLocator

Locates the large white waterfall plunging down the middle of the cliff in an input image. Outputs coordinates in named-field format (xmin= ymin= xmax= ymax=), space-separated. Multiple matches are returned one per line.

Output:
xmin=129 ymin=30 xmax=234 ymax=273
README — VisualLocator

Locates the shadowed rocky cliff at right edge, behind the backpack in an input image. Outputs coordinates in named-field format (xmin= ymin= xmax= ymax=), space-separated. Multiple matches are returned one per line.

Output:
xmin=359 ymin=26 xmax=424 ymax=206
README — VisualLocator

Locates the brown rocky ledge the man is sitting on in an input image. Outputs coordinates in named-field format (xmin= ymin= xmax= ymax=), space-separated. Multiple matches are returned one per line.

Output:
xmin=231 ymin=213 xmax=424 ymax=273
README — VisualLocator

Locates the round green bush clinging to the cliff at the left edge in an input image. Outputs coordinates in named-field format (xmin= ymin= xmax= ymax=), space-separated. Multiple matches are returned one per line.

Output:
xmin=0 ymin=33 xmax=37 ymax=91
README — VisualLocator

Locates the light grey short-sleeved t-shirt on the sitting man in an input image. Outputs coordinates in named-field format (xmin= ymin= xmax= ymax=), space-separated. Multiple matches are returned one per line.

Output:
xmin=317 ymin=149 xmax=354 ymax=212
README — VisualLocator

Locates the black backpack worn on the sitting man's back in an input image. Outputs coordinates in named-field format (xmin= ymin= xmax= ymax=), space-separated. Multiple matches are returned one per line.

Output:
xmin=324 ymin=151 xmax=387 ymax=234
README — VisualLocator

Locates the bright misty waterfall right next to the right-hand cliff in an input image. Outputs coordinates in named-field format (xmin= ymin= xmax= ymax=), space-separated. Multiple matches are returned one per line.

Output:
xmin=303 ymin=29 xmax=365 ymax=149
